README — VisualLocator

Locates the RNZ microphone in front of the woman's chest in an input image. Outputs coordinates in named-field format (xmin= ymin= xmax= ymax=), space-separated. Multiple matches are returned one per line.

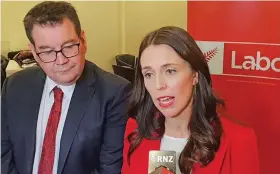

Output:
xmin=148 ymin=150 xmax=176 ymax=174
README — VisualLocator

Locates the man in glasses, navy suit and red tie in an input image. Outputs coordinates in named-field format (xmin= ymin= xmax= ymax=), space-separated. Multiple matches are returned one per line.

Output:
xmin=1 ymin=1 xmax=130 ymax=174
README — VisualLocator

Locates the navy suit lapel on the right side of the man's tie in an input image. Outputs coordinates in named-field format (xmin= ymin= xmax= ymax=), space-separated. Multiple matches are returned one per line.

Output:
xmin=57 ymin=63 xmax=95 ymax=174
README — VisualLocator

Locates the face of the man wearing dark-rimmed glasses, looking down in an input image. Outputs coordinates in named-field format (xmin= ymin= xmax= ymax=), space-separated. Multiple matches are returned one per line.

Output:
xmin=30 ymin=18 xmax=87 ymax=85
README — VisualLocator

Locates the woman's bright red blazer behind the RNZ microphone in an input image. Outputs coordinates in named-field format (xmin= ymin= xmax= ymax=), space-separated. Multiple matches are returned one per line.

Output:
xmin=122 ymin=118 xmax=259 ymax=174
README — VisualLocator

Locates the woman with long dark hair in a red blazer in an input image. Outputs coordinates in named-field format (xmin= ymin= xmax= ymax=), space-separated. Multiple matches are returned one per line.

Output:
xmin=122 ymin=27 xmax=259 ymax=174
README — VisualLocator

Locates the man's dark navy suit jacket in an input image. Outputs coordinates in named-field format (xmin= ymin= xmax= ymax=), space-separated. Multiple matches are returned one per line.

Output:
xmin=1 ymin=61 xmax=130 ymax=174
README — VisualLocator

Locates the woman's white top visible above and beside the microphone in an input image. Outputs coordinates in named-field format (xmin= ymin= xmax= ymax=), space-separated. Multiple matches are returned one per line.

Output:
xmin=160 ymin=135 xmax=188 ymax=174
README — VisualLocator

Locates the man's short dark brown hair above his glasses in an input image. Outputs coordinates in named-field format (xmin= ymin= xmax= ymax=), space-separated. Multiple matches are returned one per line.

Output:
xmin=23 ymin=1 xmax=81 ymax=44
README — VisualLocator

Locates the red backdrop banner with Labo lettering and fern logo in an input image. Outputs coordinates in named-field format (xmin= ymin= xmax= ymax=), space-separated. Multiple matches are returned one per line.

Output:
xmin=187 ymin=1 xmax=280 ymax=174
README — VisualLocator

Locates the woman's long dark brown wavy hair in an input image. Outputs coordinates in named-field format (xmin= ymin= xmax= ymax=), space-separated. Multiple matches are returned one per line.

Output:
xmin=128 ymin=26 xmax=224 ymax=174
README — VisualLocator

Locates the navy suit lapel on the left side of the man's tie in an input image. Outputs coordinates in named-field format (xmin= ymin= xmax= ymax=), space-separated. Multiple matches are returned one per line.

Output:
xmin=23 ymin=69 xmax=46 ymax=173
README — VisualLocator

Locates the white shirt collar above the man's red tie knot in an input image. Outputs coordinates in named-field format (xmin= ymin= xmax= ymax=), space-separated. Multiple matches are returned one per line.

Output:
xmin=46 ymin=76 xmax=76 ymax=99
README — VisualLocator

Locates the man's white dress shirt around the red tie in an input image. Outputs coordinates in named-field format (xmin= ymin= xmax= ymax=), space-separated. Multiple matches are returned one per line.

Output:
xmin=33 ymin=77 xmax=76 ymax=174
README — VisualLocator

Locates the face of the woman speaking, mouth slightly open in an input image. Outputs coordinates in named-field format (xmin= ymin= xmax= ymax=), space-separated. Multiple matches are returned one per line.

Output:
xmin=140 ymin=44 xmax=197 ymax=117
